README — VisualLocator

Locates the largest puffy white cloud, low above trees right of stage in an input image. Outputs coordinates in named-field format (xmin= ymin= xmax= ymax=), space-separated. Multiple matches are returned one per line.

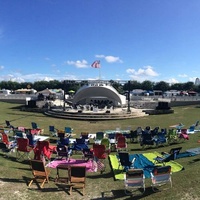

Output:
xmin=126 ymin=66 xmax=159 ymax=81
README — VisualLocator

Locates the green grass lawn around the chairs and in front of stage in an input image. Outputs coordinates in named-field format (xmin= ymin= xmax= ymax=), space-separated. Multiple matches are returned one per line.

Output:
xmin=0 ymin=102 xmax=200 ymax=200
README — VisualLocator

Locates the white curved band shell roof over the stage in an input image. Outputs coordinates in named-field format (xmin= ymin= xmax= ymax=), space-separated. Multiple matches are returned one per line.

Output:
xmin=73 ymin=82 xmax=126 ymax=106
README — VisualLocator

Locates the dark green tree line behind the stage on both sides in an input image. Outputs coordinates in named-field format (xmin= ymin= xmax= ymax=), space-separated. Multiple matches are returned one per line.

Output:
xmin=0 ymin=80 xmax=200 ymax=94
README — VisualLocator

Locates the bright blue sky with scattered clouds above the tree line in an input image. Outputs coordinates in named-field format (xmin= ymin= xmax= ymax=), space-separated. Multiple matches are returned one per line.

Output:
xmin=0 ymin=0 xmax=200 ymax=83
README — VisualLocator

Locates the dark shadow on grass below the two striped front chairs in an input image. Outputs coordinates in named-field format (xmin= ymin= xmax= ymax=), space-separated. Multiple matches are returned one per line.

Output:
xmin=91 ymin=187 xmax=154 ymax=200
